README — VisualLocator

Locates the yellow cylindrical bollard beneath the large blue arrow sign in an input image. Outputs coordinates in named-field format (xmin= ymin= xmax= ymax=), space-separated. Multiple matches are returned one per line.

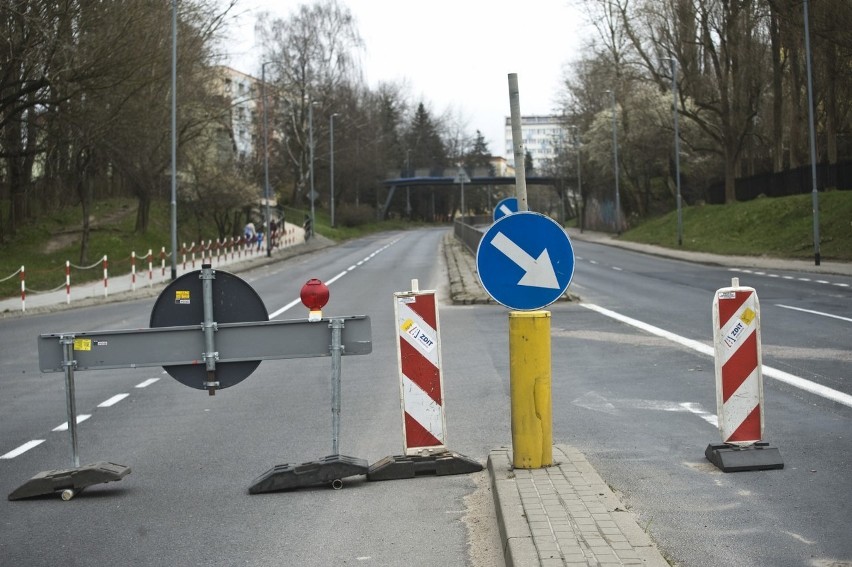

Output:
xmin=509 ymin=311 xmax=553 ymax=469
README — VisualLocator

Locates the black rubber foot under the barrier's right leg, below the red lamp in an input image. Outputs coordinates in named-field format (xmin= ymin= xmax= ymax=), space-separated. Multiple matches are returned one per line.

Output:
xmin=249 ymin=455 xmax=370 ymax=494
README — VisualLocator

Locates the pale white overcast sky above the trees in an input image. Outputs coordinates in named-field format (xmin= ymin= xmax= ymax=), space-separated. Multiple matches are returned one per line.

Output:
xmin=220 ymin=0 xmax=583 ymax=155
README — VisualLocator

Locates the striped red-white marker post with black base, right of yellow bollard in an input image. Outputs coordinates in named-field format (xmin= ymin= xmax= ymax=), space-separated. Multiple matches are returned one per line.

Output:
xmin=705 ymin=278 xmax=784 ymax=472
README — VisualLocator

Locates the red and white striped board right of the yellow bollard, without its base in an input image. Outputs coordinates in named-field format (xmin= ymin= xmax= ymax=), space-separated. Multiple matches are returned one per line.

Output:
xmin=713 ymin=278 xmax=763 ymax=446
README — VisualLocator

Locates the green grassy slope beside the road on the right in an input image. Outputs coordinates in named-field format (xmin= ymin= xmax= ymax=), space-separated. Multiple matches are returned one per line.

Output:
xmin=622 ymin=191 xmax=852 ymax=262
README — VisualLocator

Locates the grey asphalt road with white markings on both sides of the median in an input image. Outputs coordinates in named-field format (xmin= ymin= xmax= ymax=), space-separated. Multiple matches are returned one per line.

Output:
xmin=0 ymin=229 xmax=852 ymax=567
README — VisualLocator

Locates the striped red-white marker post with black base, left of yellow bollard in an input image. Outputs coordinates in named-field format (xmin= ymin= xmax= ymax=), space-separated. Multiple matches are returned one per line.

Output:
xmin=367 ymin=280 xmax=482 ymax=480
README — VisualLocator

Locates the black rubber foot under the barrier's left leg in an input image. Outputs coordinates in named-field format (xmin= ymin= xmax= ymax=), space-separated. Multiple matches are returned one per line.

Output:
xmin=9 ymin=462 xmax=130 ymax=500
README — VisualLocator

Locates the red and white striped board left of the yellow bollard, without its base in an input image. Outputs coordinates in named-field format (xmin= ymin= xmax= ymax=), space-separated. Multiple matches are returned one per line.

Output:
xmin=394 ymin=280 xmax=447 ymax=455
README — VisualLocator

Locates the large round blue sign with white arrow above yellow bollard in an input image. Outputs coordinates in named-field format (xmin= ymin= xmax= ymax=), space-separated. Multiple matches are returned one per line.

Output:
xmin=476 ymin=211 xmax=574 ymax=311
